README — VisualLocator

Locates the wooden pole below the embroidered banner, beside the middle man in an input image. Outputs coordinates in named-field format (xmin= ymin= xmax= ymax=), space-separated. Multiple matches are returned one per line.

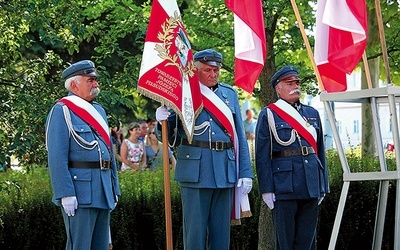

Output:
xmin=162 ymin=120 xmax=172 ymax=250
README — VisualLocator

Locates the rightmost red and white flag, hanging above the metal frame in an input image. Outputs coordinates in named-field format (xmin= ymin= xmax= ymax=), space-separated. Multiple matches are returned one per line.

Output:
xmin=314 ymin=0 xmax=368 ymax=92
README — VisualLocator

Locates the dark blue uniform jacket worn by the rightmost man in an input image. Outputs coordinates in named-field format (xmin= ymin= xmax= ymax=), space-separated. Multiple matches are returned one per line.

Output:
xmin=256 ymin=100 xmax=329 ymax=200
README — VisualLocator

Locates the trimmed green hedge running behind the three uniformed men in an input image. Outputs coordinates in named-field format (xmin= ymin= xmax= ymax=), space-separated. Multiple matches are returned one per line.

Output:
xmin=0 ymin=151 xmax=396 ymax=250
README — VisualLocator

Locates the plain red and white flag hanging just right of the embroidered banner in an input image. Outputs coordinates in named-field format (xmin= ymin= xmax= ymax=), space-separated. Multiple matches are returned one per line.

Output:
xmin=226 ymin=0 xmax=267 ymax=93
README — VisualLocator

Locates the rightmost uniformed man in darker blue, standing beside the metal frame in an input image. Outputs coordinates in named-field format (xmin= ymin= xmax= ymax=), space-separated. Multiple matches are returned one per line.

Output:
xmin=256 ymin=66 xmax=329 ymax=250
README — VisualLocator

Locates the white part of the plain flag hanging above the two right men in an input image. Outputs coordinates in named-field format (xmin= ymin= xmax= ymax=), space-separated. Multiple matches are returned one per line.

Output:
xmin=234 ymin=15 xmax=264 ymax=65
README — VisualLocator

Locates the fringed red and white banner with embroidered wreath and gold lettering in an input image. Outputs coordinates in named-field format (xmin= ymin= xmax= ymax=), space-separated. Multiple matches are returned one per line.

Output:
xmin=138 ymin=0 xmax=203 ymax=141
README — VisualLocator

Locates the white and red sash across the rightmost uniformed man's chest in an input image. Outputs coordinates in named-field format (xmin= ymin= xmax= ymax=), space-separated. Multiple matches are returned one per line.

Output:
xmin=268 ymin=99 xmax=318 ymax=154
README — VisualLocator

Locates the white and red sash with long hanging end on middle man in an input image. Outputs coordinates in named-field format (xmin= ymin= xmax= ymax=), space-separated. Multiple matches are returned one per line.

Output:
xmin=200 ymin=84 xmax=250 ymax=220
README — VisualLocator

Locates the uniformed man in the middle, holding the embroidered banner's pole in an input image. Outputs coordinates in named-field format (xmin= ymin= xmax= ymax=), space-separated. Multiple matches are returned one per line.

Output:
xmin=156 ymin=49 xmax=253 ymax=250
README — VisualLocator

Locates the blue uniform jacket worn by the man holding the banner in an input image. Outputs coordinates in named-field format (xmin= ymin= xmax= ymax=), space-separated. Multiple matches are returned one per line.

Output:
xmin=158 ymin=83 xmax=253 ymax=188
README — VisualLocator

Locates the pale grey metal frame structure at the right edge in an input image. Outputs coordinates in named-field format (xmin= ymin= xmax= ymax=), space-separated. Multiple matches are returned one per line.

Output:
xmin=320 ymin=84 xmax=400 ymax=250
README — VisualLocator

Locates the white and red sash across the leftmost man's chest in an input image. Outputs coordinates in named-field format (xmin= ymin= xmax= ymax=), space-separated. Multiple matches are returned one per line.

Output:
xmin=58 ymin=95 xmax=111 ymax=148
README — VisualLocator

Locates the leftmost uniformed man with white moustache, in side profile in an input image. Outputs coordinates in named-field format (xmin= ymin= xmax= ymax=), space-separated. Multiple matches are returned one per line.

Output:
xmin=46 ymin=60 xmax=120 ymax=250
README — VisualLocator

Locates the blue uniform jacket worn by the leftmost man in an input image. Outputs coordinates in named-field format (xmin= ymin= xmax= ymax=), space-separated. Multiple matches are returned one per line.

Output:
xmin=46 ymin=93 xmax=121 ymax=209
